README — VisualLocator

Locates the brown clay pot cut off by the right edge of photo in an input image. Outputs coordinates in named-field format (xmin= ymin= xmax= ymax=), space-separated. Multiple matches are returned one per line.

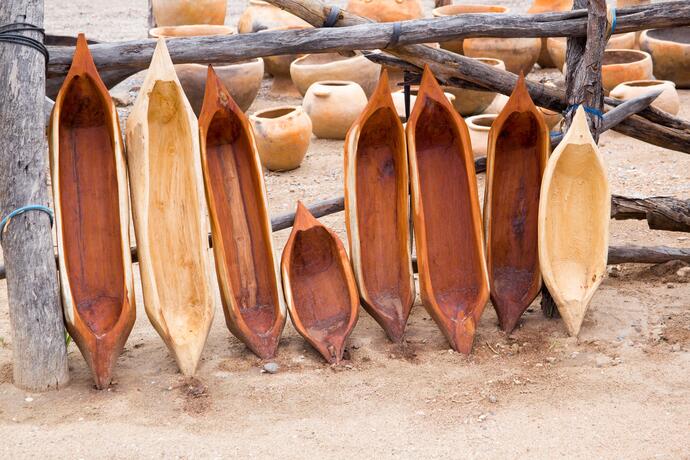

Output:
xmin=640 ymin=26 xmax=690 ymax=88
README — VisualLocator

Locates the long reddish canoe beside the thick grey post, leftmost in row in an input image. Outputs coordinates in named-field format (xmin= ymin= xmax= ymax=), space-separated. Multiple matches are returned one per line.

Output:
xmin=49 ymin=34 xmax=136 ymax=389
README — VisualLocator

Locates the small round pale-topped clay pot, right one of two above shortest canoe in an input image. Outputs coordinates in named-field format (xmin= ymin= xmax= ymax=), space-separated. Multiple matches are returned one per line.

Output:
xmin=302 ymin=81 xmax=367 ymax=139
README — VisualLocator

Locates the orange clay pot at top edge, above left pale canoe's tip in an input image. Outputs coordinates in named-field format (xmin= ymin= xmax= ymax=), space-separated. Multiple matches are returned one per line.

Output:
xmin=152 ymin=0 xmax=228 ymax=26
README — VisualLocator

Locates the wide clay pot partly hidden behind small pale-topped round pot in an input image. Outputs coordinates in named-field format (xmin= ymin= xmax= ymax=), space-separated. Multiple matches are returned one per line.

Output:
xmin=290 ymin=53 xmax=381 ymax=97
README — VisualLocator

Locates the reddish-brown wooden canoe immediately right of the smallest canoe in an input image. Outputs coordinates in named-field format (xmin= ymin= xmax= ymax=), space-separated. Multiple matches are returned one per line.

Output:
xmin=345 ymin=70 xmax=415 ymax=342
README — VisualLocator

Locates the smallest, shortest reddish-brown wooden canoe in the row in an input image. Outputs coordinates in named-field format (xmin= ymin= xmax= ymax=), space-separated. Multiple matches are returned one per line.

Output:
xmin=281 ymin=202 xmax=359 ymax=364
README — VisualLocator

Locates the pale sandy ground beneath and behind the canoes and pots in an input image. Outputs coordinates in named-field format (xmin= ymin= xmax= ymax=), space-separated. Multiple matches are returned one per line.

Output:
xmin=0 ymin=0 xmax=690 ymax=458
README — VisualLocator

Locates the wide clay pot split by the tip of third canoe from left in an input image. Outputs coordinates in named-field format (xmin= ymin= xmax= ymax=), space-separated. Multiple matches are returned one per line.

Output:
xmin=175 ymin=58 xmax=264 ymax=117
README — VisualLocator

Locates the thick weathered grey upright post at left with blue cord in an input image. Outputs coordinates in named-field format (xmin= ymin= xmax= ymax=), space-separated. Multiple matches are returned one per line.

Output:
xmin=0 ymin=0 xmax=69 ymax=391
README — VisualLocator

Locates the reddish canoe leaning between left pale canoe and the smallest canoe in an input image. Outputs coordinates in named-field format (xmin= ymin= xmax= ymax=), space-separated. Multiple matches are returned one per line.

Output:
xmin=199 ymin=66 xmax=285 ymax=359
